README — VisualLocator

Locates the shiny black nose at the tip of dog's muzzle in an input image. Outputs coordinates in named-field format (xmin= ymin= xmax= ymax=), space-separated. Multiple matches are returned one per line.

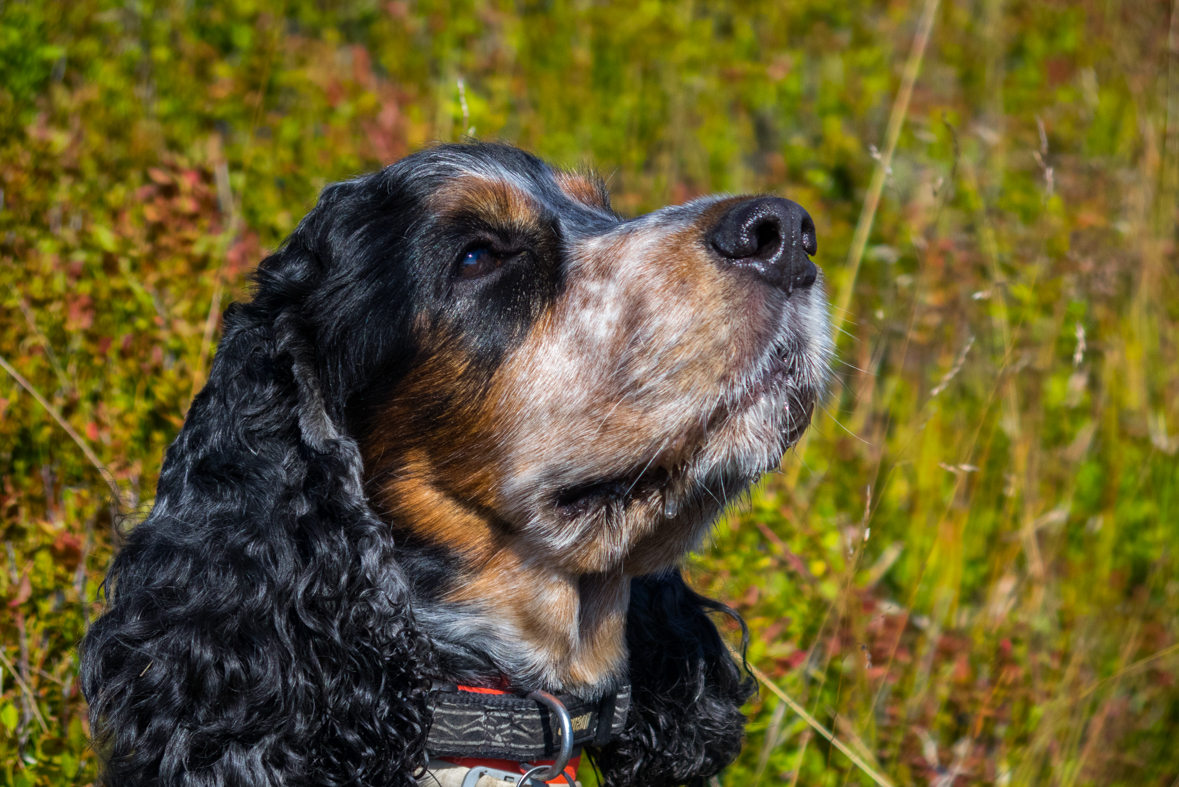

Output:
xmin=707 ymin=197 xmax=818 ymax=292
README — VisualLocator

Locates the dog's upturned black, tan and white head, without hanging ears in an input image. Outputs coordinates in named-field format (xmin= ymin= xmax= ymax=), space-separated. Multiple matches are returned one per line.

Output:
xmin=287 ymin=144 xmax=831 ymax=575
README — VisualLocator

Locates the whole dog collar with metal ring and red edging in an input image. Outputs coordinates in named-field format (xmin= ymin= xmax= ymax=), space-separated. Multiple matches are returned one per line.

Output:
xmin=426 ymin=685 xmax=631 ymax=787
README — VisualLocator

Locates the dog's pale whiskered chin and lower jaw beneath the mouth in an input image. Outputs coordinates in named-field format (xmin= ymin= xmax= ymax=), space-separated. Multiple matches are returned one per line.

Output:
xmin=545 ymin=352 xmax=819 ymax=574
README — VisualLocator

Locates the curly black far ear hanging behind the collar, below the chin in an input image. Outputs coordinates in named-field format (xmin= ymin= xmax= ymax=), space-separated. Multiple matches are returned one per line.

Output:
xmin=594 ymin=573 xmax=755 ymax=787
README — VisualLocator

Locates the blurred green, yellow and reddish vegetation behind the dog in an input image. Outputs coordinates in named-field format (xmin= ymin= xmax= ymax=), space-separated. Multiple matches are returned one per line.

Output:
xmin=0 ymin=0 xmax=1179 ymax=787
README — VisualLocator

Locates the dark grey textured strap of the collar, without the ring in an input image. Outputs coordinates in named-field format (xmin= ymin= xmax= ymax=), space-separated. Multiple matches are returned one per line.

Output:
xmin=426 ymin=685 xmax=631 ymax=762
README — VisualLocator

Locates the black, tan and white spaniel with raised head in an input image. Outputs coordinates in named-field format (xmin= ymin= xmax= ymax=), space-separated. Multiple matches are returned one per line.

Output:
xmin=81 ymin=143 xmax=831 ymax=787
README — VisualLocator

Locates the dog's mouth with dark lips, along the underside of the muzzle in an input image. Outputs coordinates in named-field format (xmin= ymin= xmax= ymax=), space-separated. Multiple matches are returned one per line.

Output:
xmin=554 ymin=348 xmax=817 ymax=520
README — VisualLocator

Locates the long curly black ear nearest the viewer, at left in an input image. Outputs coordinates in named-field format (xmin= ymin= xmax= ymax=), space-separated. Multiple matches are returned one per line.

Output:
xmin=81 ymin=222 xmax=429 ymax=787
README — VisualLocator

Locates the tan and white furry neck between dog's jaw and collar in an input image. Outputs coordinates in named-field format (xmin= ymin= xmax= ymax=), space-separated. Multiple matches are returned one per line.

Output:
xmin=399 ymin=540 xmax=630 ymax=696
